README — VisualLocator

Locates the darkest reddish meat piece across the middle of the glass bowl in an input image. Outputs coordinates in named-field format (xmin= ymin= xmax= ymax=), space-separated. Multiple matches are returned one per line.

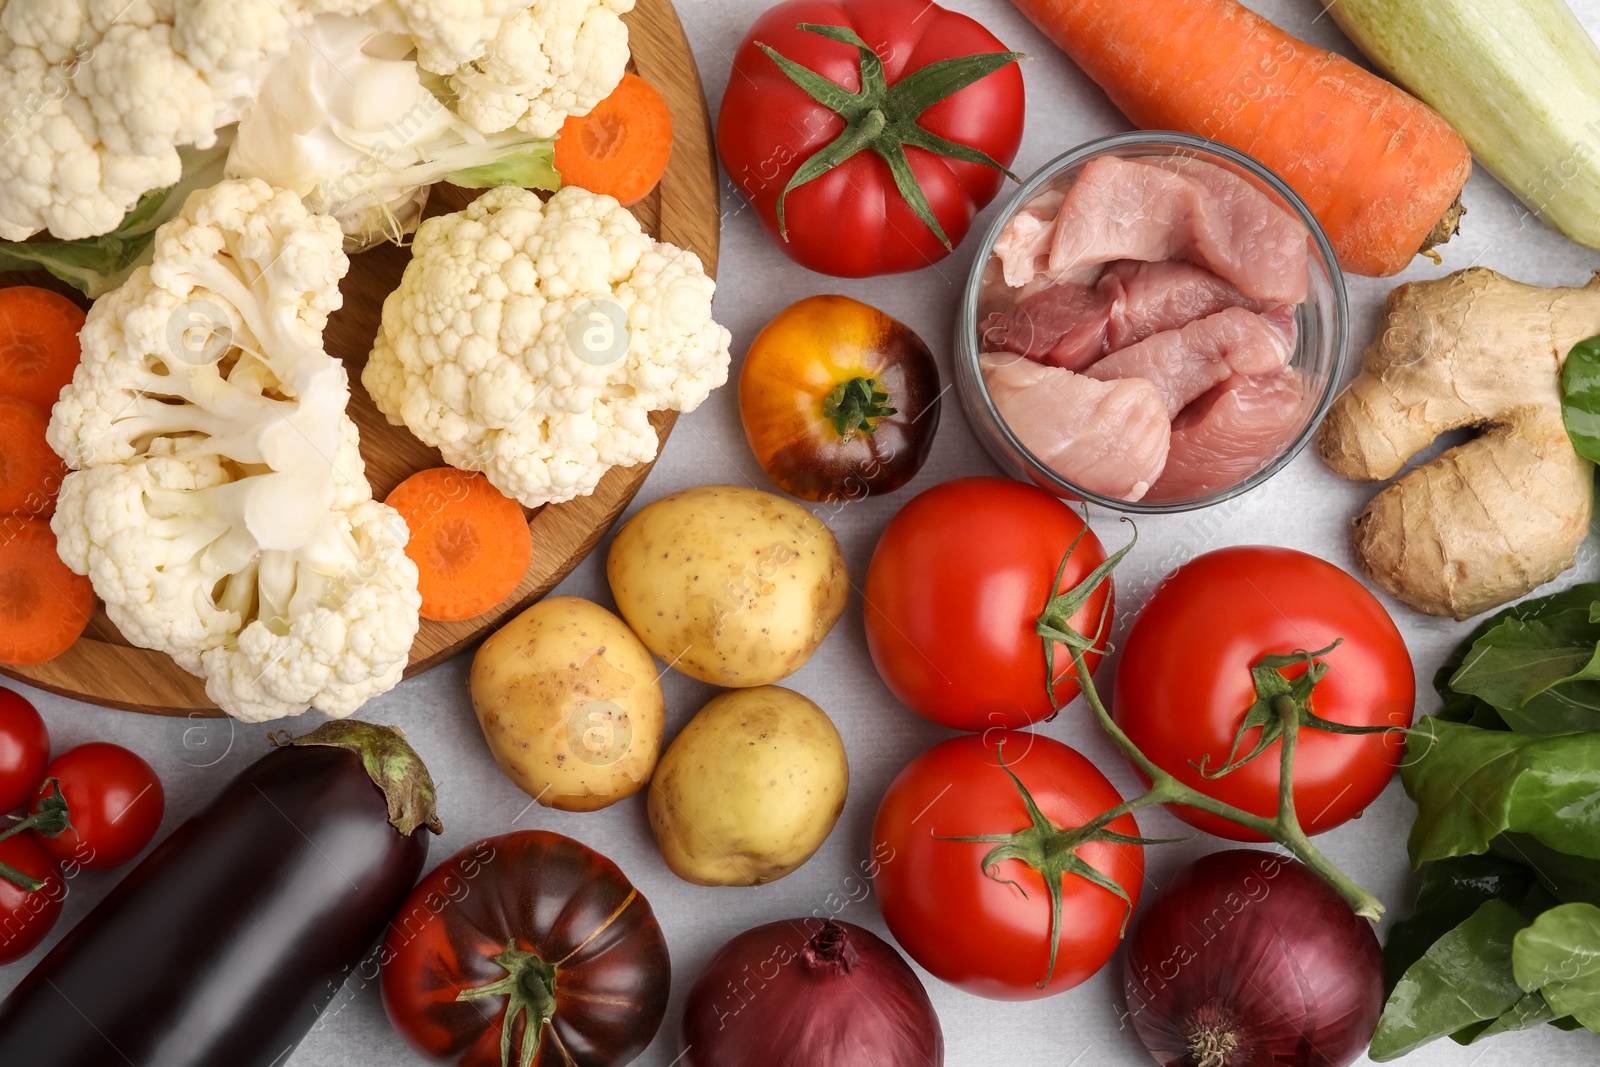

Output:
xmin=982 ymin=259 xmax=1269 ymax=371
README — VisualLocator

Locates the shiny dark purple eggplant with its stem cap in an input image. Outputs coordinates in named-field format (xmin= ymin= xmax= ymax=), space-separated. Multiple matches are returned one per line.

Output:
xmin=0 ymin=721 xmax=440 ymax=1067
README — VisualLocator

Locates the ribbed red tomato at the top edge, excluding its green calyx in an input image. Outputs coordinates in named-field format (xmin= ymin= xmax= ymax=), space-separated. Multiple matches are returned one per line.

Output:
xmin=717 ymin=0 xmax=1022 ymax=278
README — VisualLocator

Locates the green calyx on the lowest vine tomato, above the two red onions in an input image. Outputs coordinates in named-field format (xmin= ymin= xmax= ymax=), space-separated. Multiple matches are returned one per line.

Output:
xmin=934 ymin=741 xmax=1168 ymax=989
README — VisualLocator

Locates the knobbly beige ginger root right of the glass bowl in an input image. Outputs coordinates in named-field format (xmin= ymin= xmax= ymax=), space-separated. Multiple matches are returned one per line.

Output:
xmin=1317 ymin=267 xmax=1600 ymax=619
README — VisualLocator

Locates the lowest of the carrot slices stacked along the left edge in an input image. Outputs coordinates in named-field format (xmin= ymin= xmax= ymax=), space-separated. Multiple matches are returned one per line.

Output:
xmin=0 ymin=517 xmax=94 ymax=667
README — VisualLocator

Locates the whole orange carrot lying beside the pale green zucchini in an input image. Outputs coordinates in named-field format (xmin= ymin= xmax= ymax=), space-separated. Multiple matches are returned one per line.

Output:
xmin=1011 ymin=0 xmax=1472 ymax=277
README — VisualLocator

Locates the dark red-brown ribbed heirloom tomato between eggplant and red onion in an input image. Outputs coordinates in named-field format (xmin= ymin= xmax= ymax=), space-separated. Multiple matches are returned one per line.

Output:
xmin=382 ymin=830 xmax=672 ymax=1067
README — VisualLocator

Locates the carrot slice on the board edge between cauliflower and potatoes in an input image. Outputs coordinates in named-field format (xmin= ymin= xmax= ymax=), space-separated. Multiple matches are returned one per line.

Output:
xmin=386 ymin=467 xmax=533 ymax=622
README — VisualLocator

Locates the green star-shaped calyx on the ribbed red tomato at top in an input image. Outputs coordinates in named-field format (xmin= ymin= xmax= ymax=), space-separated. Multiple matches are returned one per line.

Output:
xmin=755 ymin=22 xmax=1026 ymax=250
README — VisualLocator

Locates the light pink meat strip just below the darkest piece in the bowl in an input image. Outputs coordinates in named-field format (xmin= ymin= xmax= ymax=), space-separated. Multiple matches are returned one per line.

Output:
xmin=1083 ymin=306 xmax=1296 ymax=418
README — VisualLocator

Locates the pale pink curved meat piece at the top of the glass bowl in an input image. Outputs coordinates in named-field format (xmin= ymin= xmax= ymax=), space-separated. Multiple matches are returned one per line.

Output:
xmin=1046 ymin=155 xmax=1310 ymax=304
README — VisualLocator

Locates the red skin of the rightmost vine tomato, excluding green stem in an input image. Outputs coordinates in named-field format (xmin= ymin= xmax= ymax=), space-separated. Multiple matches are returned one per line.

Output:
xmin=1112 ymin=547 xmax=1416 ymax=841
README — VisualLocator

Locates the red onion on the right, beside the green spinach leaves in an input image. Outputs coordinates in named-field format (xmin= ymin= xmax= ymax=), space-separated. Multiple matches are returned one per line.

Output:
xmin=1123 ymin=849 xmax=1384 ymax=1067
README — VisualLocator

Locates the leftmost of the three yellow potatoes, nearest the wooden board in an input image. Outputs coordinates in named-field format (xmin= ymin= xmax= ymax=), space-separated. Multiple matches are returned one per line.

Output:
xmin=470 ymin=597 xmax=666 ymax=811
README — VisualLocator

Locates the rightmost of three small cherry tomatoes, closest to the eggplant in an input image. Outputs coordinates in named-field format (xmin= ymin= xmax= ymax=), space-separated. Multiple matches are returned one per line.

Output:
xmin=38 ymin=741 xmax=166 ymax=869
